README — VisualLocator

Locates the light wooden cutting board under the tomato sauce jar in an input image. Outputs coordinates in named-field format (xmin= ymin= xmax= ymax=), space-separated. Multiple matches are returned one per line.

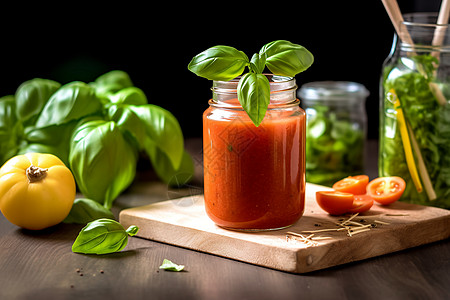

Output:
xmin=119 ymin=183 xmax=450 ymax=273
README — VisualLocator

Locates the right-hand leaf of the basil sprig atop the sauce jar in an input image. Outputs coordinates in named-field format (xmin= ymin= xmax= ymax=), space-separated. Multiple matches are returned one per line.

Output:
xmin=259 ymin=40 xmax=314 ymax=77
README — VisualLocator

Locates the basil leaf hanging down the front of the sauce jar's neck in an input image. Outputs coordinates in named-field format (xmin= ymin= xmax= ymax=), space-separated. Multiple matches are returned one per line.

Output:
xmin=237 ymin=73 xmax=270 ymax=126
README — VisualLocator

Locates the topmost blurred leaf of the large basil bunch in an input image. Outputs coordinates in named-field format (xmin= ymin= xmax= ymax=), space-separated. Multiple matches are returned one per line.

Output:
xmin=90 ymin=70 xmax=133 ymax=96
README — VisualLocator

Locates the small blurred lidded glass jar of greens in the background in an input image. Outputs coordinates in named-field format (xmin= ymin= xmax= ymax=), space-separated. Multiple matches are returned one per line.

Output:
xmin=298 ymin=81 xmax=369 ymax=186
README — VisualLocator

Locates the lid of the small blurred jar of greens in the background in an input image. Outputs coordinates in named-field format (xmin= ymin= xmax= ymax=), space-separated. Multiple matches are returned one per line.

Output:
xmin=297 ymin=81 xmax=369 ymax=103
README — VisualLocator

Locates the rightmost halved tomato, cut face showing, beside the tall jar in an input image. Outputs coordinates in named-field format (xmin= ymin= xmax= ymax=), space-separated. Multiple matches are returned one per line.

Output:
xmin=367 ymin=176 xmax=406 ymax=205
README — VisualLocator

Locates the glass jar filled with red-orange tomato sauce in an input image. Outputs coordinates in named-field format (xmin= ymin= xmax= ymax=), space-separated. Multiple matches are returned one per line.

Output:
xmin=203 ymin=74 xmax=306 ymax=231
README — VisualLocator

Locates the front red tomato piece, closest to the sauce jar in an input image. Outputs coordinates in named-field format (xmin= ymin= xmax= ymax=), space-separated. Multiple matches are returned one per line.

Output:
xmin=316 ymin=191 xmax=354 ymax=215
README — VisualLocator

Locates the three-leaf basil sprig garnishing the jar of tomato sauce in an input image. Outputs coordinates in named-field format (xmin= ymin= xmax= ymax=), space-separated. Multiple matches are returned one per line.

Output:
xmin=188 ymin=40 xmax=314 ymax=126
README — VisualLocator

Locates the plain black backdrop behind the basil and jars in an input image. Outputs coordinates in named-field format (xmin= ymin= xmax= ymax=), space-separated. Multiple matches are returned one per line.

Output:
xmin=0 ymin=0 xmax=440 ymax=138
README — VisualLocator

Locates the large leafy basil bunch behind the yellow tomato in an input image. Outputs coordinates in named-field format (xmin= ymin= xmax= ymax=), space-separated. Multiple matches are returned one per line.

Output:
xmin=0 ymin=70 xmax=194 ymax=208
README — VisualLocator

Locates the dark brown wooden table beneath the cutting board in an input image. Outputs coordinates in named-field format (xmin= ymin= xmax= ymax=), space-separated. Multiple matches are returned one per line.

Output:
xmin=0 ymin=140 xmax=450 ymax=300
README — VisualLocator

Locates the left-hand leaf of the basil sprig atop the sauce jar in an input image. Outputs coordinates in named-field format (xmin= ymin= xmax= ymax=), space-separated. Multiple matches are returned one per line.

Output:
xmin=188 ymin=46 xmax=249 ymax=81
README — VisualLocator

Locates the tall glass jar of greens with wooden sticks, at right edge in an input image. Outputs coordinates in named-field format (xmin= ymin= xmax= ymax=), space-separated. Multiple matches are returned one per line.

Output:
xmin=378 ymin=13 xmax=450 ymax=208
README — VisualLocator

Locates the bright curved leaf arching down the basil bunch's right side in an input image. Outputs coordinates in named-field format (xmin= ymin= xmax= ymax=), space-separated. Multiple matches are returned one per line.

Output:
xmin=130 ymin=104 xmax=184 ymax=169
